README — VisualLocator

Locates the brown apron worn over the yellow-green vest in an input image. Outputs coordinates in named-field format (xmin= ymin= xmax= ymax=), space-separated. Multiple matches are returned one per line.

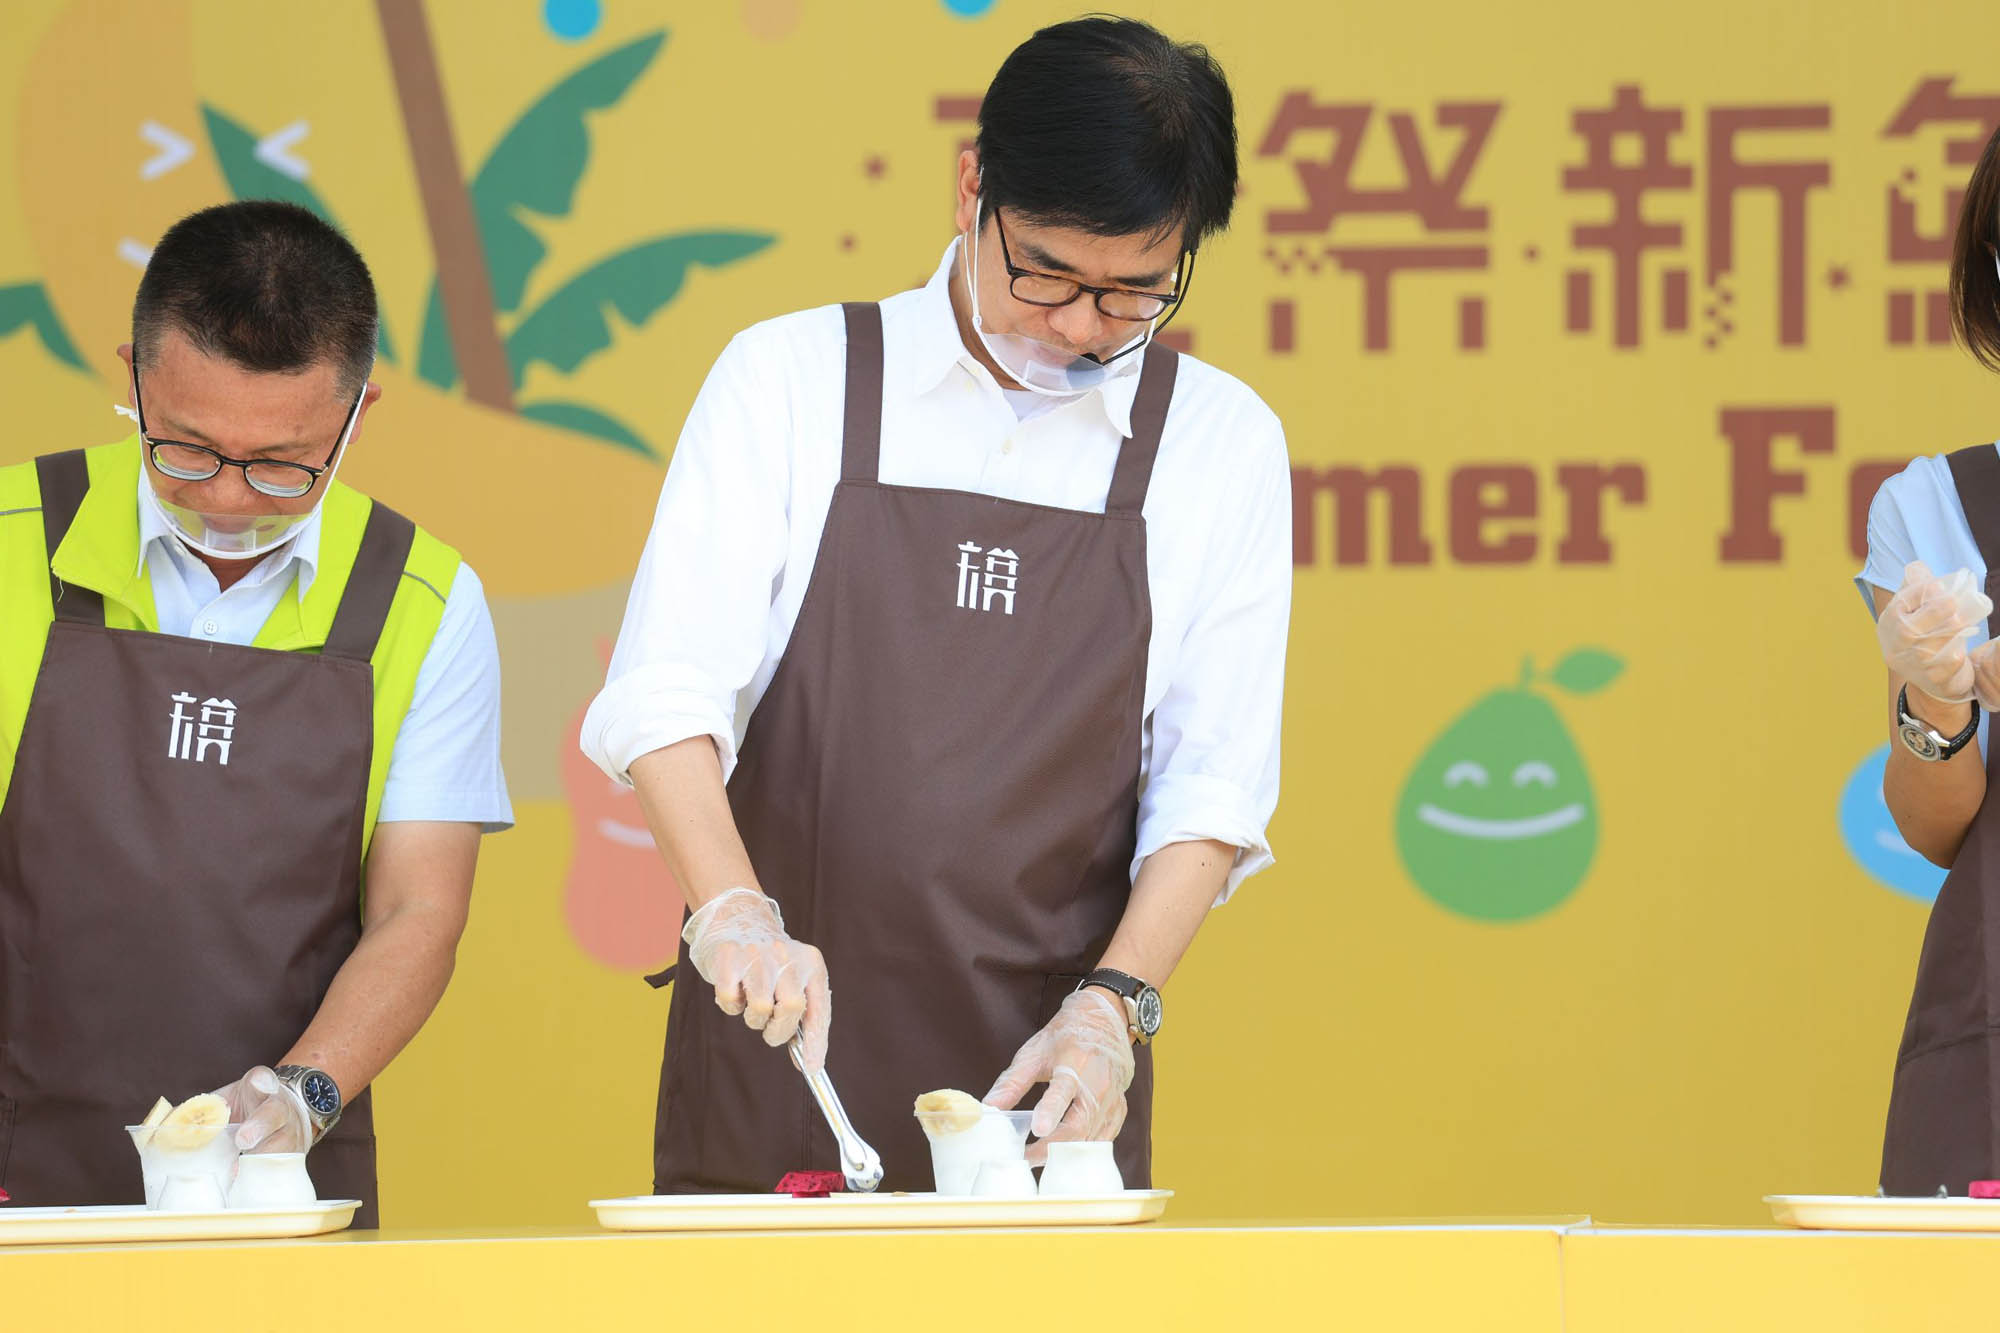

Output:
xmin=0 ymin=452 xmax=414 ymax=1227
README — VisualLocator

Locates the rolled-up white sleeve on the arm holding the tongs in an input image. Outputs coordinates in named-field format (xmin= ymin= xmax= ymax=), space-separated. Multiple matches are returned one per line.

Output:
xmin=580 ymin=326 xmax=792 ymax=785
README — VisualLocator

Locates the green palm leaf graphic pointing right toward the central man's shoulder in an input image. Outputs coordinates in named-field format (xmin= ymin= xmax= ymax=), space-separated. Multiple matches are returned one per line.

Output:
xmin=506 ymin=232 xmax=774 ymax=388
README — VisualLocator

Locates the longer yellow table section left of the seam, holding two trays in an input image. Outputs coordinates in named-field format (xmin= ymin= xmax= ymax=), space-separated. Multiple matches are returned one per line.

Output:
xmin=11 ymin=1223 xmax=1562 ymax=1333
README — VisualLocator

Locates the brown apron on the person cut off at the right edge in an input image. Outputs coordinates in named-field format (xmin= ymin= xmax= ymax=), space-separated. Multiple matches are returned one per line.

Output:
xmin=1882 ymin=444 xmax=2000 ymax=1195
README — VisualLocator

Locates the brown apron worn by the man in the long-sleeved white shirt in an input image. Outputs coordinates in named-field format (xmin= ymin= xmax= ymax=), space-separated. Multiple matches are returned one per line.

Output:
xmin=654 ymin=304 xmax=1176 ymax=1193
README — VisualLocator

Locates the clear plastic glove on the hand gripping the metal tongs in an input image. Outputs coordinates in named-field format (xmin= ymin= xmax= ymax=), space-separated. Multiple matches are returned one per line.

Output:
xmin=680 ymin=889 xmax=834 ymax=1073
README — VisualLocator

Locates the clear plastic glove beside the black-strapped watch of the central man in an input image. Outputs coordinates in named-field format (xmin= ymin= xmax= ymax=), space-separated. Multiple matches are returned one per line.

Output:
xmin=986 ymin=987 xmax=1134 ymax=1165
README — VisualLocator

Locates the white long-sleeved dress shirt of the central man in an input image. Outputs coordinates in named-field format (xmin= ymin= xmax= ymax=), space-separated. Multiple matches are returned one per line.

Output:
xmin=582 ymin=242 xmax=1292 ymax=901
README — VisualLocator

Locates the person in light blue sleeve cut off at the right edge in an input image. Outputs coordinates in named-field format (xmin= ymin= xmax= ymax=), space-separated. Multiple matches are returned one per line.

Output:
xmin=1856 ymin=132 xmax=2000 ymax=1197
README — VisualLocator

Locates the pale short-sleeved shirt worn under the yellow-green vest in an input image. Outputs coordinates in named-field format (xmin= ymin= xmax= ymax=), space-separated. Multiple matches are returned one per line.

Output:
xmin=138 ymin=468 xmax=514 ymax=833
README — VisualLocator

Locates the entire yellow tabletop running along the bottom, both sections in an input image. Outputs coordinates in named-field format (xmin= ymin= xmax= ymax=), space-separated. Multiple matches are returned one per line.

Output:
xmin=0 ymin=1219 xmax=2000 ymax=1333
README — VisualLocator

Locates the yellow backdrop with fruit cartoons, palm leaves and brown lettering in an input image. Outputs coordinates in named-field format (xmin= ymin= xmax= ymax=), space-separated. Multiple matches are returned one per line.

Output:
xmin=0 ymin=0 xmax=2000 ymax=1225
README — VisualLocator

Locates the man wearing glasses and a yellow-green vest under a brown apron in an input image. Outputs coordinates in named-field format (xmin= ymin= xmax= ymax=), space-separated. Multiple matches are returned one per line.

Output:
xmin=0 ymin=202 xmax=512 ymax=1227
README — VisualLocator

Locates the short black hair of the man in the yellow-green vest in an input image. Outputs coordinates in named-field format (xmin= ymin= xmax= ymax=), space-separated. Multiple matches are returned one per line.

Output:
xmin=132 ymin=198 xmax=378 ymax=394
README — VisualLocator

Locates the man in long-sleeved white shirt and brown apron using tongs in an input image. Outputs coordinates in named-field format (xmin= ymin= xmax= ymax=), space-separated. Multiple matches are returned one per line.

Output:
xmin=582 ymin=18 xmax=1292 ymax=1193
